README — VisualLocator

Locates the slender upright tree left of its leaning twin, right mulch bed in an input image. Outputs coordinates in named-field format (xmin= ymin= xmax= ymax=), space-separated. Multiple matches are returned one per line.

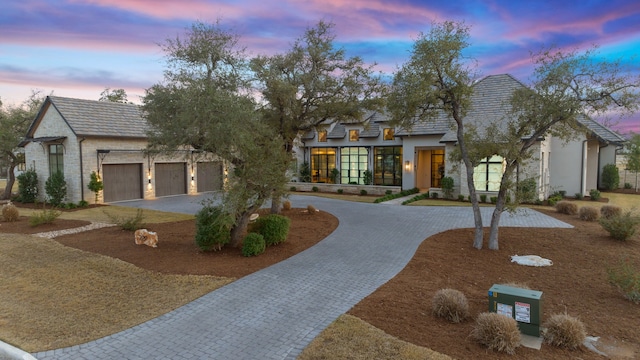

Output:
xmin=389 ymin=21 xmax=484 ymax=249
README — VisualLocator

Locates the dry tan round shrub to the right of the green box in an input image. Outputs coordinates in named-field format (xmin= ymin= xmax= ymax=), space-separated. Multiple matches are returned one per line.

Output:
xmin=542 ymin=314 xmax=587 ymax=350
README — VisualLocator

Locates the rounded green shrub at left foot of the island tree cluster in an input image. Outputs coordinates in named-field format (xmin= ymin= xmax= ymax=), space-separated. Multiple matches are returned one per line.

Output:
xmin=195 ymin=205 xmax=233 ymax=251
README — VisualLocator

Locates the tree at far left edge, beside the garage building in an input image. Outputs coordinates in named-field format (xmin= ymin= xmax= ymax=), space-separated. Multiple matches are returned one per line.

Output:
xmin=0 ymin=91 xmax=44 ymax=199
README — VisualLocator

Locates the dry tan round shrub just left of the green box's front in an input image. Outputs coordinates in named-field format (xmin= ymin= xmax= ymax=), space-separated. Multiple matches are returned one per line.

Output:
xmin=471 ymin=312 xmax=521 ymax=354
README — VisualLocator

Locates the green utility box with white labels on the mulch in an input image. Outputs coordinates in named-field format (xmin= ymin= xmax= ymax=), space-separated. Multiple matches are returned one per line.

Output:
xmin=489 ymin=284 xmax=542 ymax=337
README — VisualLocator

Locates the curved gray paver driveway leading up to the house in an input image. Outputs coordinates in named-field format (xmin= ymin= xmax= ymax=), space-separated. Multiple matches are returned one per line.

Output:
xmin=35 ymin=196 xmax=570 ymax=359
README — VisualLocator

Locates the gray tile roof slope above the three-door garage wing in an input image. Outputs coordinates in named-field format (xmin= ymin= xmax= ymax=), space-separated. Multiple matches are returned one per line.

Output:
xmin=41 ymin=96 xmax=148 ymax=138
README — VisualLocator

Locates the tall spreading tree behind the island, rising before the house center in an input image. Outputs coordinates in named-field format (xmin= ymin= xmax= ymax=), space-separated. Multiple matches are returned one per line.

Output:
xmin=251 ymin=21 xmax=384 ymax=212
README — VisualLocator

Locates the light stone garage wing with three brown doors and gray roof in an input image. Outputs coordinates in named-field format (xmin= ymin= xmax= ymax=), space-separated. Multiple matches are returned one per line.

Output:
xmin=23 ymin=96 xmax=225 ymax=203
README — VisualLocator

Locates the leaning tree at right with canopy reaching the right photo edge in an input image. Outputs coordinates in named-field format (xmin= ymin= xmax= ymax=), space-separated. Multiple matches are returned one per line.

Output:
xmin=484 ymin=45 xmax=640 ymax=249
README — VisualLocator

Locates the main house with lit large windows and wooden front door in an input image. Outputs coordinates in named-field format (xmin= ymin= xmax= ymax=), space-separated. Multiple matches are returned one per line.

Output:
xmin=298 ymin=74 xmax=625 ymax=199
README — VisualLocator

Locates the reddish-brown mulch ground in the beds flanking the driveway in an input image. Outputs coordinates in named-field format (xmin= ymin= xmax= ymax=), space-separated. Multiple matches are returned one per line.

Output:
xmin=5 ymin=201 xmax=640 ymax=359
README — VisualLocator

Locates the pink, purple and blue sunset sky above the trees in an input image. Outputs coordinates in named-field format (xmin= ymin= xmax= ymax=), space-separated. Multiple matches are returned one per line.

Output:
xmin=0 ymin=0 xmax=640 ymax=133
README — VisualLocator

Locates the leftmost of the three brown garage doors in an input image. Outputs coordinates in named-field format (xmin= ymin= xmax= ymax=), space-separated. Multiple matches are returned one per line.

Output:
xmin=102 ymin=164 xmax=143 ymax=202
